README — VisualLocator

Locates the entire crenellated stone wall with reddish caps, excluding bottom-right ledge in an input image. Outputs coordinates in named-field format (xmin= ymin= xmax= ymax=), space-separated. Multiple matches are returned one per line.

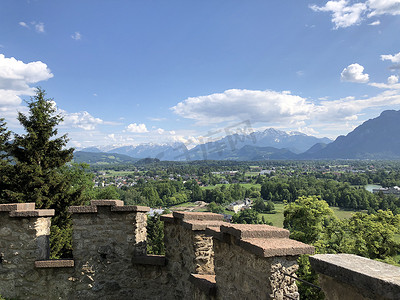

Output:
xmin=0 ymin=200 xmax=396 ymax=299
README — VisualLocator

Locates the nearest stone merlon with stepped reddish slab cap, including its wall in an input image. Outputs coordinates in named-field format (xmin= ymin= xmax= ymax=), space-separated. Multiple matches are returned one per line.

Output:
xmin=211 ymin=224 xmax=314 ymax=299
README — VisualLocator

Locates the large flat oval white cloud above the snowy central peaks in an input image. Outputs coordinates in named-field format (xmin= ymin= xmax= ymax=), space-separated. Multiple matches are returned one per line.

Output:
xmin=171 ymin=89 xmax=313 ymax=124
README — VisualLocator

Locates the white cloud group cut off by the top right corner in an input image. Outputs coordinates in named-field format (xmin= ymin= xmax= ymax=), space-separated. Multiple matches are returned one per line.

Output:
xmin=310 ymin=0 xmax=400 ymax=29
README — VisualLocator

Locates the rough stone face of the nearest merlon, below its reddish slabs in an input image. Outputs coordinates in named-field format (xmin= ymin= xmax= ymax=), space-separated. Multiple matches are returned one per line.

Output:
xmin=214 ymin=240 xmax=299 ymax=300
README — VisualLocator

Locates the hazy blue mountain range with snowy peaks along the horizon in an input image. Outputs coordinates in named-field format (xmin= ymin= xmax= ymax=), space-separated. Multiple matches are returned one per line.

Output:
xmin=75 ymin=110 xmax=400 ymax=161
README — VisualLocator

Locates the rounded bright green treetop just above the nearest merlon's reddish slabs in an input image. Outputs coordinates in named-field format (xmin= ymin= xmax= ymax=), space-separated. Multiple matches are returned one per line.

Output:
xmin=283 ymin=196 xmax=333 ymax=244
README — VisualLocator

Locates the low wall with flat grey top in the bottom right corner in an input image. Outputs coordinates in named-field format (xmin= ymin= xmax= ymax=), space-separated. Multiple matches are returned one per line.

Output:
xmin=310 ymin=254 xmax=400 ymax=300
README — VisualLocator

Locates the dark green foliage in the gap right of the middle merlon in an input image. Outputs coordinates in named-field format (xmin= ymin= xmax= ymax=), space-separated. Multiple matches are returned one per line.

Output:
xmin=147 ymin=214 xmax=165 ymax=255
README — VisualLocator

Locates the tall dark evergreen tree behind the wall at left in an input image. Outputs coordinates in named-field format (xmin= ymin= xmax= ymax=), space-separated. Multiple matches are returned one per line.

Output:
xmin=0 ymin=88 xmax=86 ymax=258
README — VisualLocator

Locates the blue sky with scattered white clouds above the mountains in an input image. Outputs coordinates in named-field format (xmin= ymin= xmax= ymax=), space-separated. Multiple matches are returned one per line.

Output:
xmin=0 ymin=0 xmax=400 ymax=147
